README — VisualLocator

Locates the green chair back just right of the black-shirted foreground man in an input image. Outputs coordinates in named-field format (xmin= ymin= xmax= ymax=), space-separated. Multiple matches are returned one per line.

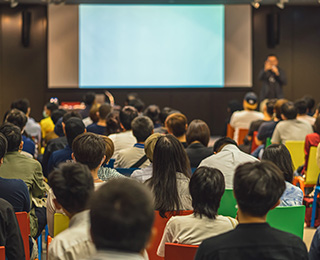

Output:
xmin=267 ymin=206 xmax=306 ymax=239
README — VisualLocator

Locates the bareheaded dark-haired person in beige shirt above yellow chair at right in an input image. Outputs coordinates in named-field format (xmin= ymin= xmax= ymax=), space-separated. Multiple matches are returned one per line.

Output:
xmin=271 ymin=102 xmax=313 ymax=143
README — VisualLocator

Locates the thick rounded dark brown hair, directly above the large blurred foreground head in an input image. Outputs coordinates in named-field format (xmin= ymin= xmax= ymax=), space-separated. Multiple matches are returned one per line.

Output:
xmin=72 ymin=133 xmax=106 ymax=170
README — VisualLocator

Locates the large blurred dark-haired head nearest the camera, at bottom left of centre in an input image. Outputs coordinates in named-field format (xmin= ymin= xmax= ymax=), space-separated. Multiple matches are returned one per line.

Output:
xmin=90 ymin=178 xmax=154 ymax=253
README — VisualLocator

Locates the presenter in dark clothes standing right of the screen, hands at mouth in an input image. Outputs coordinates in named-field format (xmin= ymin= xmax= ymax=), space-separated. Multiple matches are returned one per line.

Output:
xmin=259 ymin=54 xmax=287 ymax=101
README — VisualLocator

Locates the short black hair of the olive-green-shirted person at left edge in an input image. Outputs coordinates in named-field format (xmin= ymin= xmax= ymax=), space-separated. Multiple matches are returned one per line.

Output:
xmin=0 ymin=122 xmax=22 ymax=152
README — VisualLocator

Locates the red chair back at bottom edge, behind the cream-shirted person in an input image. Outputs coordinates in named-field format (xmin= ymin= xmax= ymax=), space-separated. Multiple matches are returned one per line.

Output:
xmin=164 ymin=243 xmax=199 ymax=260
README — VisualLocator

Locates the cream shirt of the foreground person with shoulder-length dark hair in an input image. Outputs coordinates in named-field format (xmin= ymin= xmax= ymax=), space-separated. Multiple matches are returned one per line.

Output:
xmin=157 ymin=214 xmax=238 ymax=257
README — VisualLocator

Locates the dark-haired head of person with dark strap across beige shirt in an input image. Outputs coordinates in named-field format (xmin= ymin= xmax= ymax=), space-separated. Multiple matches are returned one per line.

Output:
xmin=131 ymin=116 xmax=153 ymax=143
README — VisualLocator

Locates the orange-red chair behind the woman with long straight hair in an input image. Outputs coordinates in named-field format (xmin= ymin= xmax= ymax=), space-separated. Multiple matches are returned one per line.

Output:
xmin=147 ymin=210 xmax=193 ymax=260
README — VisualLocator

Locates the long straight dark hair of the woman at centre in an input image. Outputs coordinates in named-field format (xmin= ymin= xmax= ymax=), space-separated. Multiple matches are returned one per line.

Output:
xmin=148 ymin=135 xmax=190 ymax=217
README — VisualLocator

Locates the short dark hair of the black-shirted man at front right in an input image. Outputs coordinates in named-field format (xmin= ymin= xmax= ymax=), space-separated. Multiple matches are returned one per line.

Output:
xmin=233 ymin=161 xmax=286 ymax=217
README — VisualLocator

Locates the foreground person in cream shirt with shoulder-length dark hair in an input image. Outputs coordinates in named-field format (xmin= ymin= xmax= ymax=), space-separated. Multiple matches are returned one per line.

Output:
xmin=157 ymin=167 xmax=238 ymax=257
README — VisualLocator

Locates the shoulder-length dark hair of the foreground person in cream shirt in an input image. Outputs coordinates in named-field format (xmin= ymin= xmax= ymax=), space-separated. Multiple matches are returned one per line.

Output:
xmin=189 ymin=167 xmax=225 ymax=219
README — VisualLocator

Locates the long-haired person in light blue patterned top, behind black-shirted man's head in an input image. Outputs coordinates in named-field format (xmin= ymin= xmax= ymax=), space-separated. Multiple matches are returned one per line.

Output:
xmin=262 ymin=144 xmax=303 ymax=206
